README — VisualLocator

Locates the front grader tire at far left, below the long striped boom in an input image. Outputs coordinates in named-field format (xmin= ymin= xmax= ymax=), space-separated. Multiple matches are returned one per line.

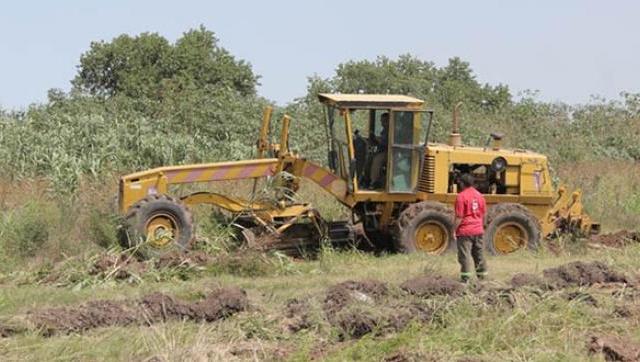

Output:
xmin=121 ymin=195 xmax=195 ymax=258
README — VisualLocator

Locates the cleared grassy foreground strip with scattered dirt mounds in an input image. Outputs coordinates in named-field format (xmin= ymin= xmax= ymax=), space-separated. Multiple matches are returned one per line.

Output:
xmin=0 ymin=230 xmax=640 ymax=361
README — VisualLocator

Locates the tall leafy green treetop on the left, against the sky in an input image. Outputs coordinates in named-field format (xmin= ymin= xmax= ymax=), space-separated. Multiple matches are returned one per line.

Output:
xmin=72 ymin=27 xmax=258 ymax=101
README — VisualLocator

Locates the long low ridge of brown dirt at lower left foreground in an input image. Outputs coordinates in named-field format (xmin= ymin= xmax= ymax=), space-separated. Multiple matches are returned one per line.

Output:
xmin=27 ymin=288 xmax=248 ymax=336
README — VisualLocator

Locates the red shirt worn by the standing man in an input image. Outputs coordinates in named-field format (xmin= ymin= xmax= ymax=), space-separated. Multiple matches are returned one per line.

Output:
xmin=456 ymin=187 xmax=486 ymax=236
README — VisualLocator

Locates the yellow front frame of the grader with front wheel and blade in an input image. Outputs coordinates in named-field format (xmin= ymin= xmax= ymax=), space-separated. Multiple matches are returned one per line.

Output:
xmin=119 ymin=113 xmax=348 ymax=255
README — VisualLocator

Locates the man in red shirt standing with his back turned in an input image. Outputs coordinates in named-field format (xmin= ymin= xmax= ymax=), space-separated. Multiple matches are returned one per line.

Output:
xmin=454 ymin=173 xmax=487 ymax=282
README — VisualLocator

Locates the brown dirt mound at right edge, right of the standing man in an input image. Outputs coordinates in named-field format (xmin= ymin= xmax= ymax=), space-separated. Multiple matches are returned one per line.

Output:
xmin=543 ymin=261 xmax=628 ymax=288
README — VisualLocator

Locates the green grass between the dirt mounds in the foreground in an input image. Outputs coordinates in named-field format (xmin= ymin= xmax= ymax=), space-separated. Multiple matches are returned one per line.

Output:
xmin=0 ymin=246 xmax=640 ymax=361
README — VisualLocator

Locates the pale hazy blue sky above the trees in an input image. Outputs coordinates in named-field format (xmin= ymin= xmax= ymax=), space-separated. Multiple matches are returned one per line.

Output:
xmin=0 ymin=0 xmax=640 ymax=108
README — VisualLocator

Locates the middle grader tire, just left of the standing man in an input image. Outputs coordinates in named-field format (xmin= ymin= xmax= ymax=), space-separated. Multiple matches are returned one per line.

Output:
xmin=394 ymin=201 xmax=455 ymax=255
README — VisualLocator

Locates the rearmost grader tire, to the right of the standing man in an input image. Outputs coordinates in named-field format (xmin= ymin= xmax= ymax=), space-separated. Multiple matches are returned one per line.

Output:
xmin=484 ymin=203 xmax=541 ymax=255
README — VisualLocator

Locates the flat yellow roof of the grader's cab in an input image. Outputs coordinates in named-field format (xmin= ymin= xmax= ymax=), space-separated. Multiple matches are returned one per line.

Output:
xmin=318 ymin=93 xmax=424 ymax=108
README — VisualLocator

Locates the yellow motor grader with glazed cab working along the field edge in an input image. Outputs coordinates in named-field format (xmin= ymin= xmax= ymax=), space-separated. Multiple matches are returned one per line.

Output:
xmin=118 ymin=94 xmax=598 ymax=254
